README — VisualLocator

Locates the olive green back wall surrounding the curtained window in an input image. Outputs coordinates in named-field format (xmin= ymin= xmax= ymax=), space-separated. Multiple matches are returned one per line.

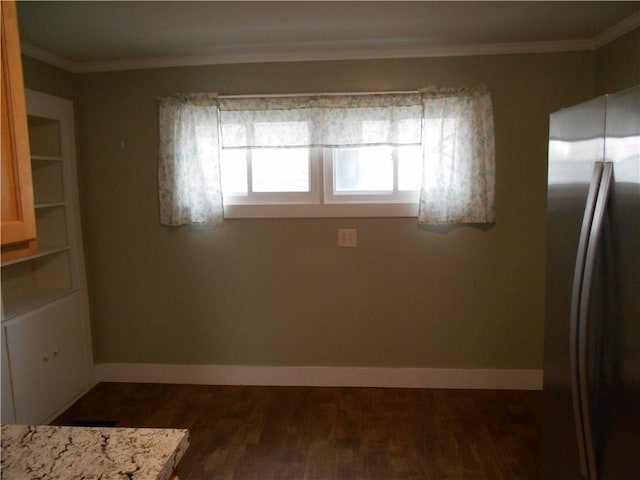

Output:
xmin=25 ymin=28 xmax=636 ymax=369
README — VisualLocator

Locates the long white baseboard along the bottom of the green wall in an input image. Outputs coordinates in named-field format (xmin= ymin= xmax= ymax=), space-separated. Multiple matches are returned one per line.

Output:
xmin=94 ymin=363 xmax=542 ymax=390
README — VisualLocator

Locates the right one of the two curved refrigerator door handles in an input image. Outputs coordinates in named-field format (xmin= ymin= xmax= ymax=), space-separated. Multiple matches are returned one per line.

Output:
xmin=578 ymin=162 xmax=613 ymax=480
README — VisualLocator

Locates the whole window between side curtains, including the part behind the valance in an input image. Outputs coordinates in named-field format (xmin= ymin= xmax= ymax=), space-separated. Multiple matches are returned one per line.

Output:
xmin=220 ymin=94 xmax=422 ymax=217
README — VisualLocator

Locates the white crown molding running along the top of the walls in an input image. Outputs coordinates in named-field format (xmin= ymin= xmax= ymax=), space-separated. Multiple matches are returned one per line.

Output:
xmin=22 ymin=12 xmax=640 ymax=73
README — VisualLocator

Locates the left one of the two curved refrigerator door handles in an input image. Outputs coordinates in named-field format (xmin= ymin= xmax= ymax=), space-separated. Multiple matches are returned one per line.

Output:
xmin=569 ymin=162 xmax=603 ymax=478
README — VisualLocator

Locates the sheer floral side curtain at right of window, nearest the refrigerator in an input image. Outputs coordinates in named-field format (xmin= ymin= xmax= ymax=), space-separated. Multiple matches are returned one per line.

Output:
xmin=418 ymin=85 xmax=495 ymax=225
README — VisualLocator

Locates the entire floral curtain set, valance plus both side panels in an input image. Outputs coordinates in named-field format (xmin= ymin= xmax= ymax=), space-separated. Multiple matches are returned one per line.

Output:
xmin=159 ymin=85 xmax=495 ymax=225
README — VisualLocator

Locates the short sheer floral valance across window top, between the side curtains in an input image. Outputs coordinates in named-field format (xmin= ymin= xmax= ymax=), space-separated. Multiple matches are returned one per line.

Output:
xmin=219 ymin=94 xmax=422 ymax=148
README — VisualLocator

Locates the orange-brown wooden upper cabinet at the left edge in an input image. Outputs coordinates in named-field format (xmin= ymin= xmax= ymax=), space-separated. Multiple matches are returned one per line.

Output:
xmin=1 ymin=1 xmax=38 ymax=262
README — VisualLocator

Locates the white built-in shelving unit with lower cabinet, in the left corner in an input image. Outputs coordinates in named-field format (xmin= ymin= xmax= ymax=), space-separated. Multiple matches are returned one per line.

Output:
xmin=2 ymin=90 xmax=93 ymax=424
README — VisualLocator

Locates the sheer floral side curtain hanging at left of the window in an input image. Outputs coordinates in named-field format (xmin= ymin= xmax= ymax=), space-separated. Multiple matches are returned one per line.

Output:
xmin=158 ymin=93 xmax=224 ymax=226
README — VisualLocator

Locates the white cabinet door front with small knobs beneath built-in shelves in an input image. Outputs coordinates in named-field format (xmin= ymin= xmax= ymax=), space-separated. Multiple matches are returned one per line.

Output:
xmin=6 ymin=293 xmax=90 ymax=424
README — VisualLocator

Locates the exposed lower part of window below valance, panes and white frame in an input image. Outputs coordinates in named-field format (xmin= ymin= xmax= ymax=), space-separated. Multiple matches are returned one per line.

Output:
xmin=220 ymin=142 xmax=422 ymax=217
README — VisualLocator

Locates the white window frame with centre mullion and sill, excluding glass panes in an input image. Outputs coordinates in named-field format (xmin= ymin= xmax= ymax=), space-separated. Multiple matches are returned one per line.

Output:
xmin=224 ymin=148 xmax=419 ymax=218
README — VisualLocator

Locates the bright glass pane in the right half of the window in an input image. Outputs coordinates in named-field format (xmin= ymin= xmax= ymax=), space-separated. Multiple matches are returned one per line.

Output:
xmin=333 ymin=147 xmax=393 ymax=192
